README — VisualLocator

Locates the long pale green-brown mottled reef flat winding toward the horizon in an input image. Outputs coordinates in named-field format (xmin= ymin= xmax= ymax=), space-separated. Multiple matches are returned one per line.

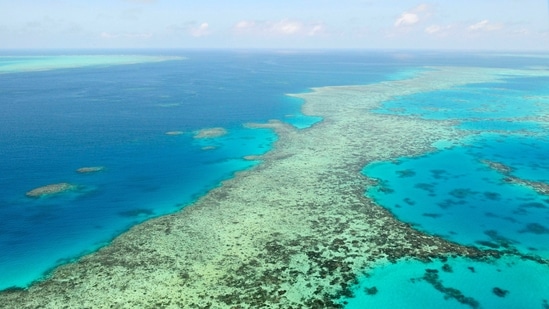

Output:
xmin=0 ymin=68 xmax=544 ymax=308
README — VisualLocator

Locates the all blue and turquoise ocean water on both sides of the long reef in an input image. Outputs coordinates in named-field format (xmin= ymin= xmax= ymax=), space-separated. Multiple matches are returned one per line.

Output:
xmin=0 ymin=51 xmax=549 ymax=308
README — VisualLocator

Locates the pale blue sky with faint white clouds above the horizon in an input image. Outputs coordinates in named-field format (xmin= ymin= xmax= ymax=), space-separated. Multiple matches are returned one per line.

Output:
xmin=0 ymin=0 xmax=549 ymax=51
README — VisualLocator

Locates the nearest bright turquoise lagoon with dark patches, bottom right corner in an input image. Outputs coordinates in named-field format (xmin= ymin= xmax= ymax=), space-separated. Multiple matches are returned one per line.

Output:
xmin=341 ymin=257 xmax=549 ymax=309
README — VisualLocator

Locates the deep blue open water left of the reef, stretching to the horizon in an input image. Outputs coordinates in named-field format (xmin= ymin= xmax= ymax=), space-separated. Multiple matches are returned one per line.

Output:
xmin=0 ymin=51 xmax=416 ymax=289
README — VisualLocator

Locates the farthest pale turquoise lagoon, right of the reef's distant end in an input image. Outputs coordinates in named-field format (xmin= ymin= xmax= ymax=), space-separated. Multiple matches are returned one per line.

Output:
xmin=376 ymin=77 xmax=549 ymax=120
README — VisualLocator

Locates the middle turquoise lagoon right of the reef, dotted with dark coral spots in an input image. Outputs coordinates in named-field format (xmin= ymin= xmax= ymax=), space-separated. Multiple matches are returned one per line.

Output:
xmin=364 ymin=134 xmax=549 ymax=258
